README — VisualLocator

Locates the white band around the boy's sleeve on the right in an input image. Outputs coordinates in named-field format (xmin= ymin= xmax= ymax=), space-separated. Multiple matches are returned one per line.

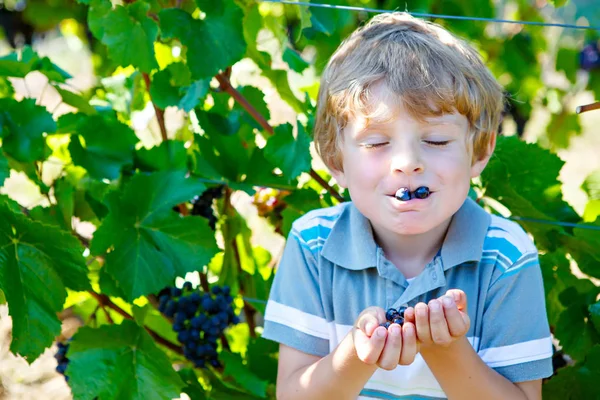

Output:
xmin=478 ymin=336 xmax=552 ymax=368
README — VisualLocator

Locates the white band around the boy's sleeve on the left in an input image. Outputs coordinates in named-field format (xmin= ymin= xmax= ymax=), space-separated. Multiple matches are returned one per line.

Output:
xmin=265 ymin=300 xmax=333 ymax=339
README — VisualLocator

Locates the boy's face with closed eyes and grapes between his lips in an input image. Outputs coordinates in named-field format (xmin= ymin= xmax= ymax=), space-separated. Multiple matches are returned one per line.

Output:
xmin=333 ymin=85 xmax=495 ymax=235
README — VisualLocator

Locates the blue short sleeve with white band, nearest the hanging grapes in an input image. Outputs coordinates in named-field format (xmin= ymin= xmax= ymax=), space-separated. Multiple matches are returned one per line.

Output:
xmin=262 ymin=228 xmax=329 ymax=357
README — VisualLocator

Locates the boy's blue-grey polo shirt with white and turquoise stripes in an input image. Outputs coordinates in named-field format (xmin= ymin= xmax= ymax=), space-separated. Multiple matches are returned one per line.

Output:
xmin=263 ymin=198 xmax=552 ymax=399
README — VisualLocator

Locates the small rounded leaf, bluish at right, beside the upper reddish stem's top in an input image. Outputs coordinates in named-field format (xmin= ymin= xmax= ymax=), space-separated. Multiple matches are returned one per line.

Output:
xmin=150 ymin=63 xmax=210 ymax=112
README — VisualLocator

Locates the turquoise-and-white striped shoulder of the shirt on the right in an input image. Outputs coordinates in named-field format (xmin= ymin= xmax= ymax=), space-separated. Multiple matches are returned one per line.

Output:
xmin=482 ymin=215 xmax=538 ymax=274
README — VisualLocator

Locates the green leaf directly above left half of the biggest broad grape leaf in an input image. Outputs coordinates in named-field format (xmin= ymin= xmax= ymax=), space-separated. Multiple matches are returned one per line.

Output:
xmin=58 ymin=114 xmax=138 ymax=180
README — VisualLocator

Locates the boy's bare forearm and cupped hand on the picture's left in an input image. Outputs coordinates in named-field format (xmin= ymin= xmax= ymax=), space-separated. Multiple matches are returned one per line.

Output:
xmin=277 ymin=307 xmax=417 ymax=400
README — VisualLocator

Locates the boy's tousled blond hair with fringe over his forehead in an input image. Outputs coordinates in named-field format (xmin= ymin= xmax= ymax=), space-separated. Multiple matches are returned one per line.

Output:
xmin=314 ymin=12 xmax=504 ymax=171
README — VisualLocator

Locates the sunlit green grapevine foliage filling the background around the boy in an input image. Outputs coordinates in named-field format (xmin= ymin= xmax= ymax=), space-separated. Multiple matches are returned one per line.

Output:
xmin=0 ymin=0 xmax=600 ymax=399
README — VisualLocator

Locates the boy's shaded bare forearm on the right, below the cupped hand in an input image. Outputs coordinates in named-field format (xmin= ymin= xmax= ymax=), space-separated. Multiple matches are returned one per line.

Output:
xmin=421 ymin=336 xmax=542 ymax=400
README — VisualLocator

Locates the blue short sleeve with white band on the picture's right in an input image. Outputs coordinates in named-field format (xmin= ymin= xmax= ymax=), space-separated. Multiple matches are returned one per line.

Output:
xmin=478 ymin=251 xmax=553 ymax=382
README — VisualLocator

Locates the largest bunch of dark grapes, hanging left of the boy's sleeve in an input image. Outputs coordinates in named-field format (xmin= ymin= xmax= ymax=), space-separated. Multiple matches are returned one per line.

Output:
xmin=158 ymin=282 xmax=240 ymax=368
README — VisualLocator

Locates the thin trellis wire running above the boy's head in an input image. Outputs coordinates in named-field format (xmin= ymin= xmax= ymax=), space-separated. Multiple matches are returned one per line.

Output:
xmin=258 ymin=0 xmax=600 ymax=31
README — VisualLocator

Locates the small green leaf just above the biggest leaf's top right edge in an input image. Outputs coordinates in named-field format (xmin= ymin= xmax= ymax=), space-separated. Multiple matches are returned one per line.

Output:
xmin=135 ymin=140 xmax=187 ymax=172
